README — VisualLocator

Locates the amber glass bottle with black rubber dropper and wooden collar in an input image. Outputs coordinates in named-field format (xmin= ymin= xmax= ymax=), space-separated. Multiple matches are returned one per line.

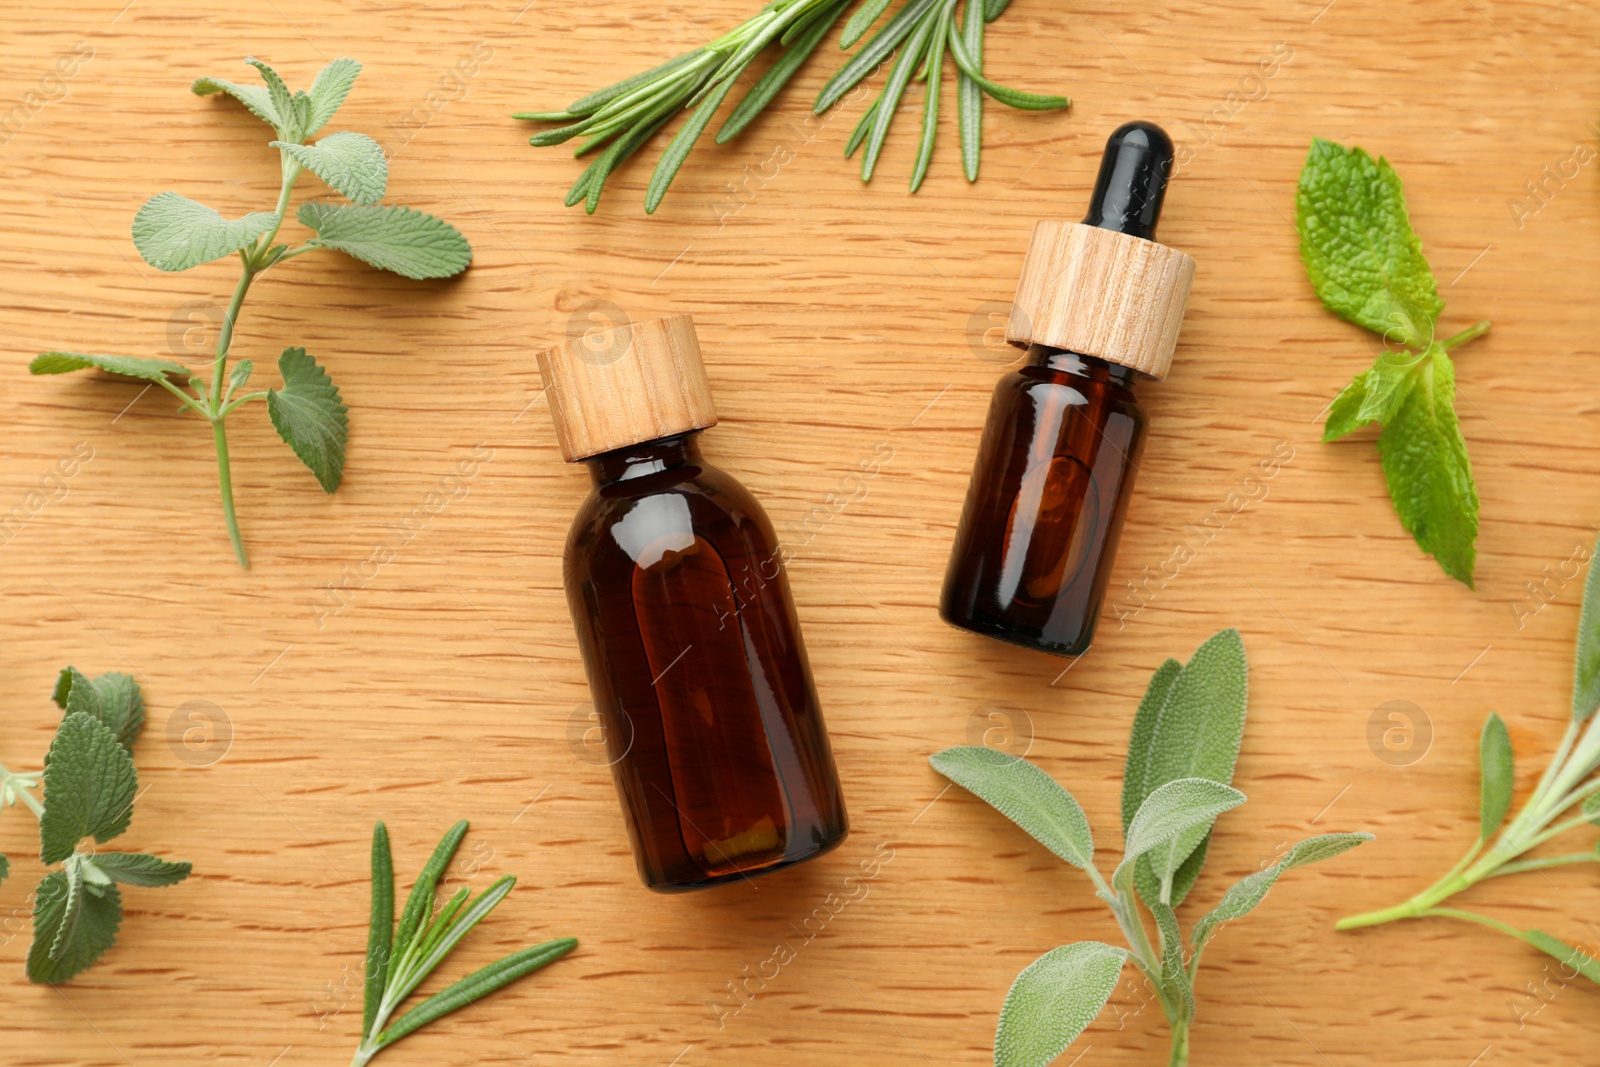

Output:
xmin=939 ymin=122 xmax=1195 ymax=656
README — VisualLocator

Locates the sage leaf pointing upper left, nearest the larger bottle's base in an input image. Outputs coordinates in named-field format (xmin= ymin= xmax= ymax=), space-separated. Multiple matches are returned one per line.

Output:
xmin=928 ymin=745 xmax=1094 ymax=869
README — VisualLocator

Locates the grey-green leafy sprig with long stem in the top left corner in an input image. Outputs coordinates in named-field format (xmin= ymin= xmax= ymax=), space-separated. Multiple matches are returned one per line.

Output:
xmin=29 ymin=59 xmax=472 ymax=566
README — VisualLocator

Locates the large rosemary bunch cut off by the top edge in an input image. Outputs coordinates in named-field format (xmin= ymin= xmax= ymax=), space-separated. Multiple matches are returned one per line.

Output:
xmin=512 ymin=0 xmax=1072 ymax=214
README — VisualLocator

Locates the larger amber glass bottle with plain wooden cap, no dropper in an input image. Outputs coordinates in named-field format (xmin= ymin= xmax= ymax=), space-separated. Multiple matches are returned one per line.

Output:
xmin=539 ymin=315 xmax=846 ymax=891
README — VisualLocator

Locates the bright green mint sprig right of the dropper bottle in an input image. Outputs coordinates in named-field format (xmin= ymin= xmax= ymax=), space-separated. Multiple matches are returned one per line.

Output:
xmin=1294 ymin=138 xmax=1490 ymax=587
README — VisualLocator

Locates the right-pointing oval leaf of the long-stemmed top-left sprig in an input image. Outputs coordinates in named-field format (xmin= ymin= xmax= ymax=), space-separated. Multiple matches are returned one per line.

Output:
xmin=299 ymin=200 xmax=472 ymax=278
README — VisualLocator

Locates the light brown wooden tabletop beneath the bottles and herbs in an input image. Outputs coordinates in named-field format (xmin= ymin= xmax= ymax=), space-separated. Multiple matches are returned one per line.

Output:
xmin=0 ymin=0 xmax=1600 ymax=1067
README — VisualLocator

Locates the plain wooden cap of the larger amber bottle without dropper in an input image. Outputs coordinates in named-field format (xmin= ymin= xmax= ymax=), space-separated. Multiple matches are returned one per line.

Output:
xmin=538 ymin=308 xmax=717 ymax=462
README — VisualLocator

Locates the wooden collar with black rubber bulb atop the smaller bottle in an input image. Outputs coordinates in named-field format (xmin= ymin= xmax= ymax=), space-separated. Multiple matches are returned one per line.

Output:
xmin=1006 ymin=122 xmax=1195 ymax=378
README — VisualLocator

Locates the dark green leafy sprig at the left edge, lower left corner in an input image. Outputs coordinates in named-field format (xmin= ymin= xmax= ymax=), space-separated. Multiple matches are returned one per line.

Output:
xmin=0 ymin=667 xmax=190 ymax=984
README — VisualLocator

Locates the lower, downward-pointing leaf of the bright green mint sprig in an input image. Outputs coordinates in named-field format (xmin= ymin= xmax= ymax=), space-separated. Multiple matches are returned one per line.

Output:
xmin=1378 ymin=344 xmax=1478 ymax=587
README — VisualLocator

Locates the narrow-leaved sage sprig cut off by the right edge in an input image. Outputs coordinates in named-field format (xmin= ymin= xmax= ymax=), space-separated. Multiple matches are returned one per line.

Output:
xmin=1338 ymin=531 xmax=1600 ymax=982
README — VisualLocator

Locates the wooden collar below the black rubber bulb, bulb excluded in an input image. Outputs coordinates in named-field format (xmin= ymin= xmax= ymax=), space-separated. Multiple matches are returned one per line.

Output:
xmin=1006 ymin=221 xmax=1195 ymax=378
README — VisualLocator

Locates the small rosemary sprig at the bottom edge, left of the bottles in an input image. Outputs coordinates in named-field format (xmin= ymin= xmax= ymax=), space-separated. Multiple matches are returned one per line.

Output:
xmin=350 ymin=819 xmax=578 ymax=1067
